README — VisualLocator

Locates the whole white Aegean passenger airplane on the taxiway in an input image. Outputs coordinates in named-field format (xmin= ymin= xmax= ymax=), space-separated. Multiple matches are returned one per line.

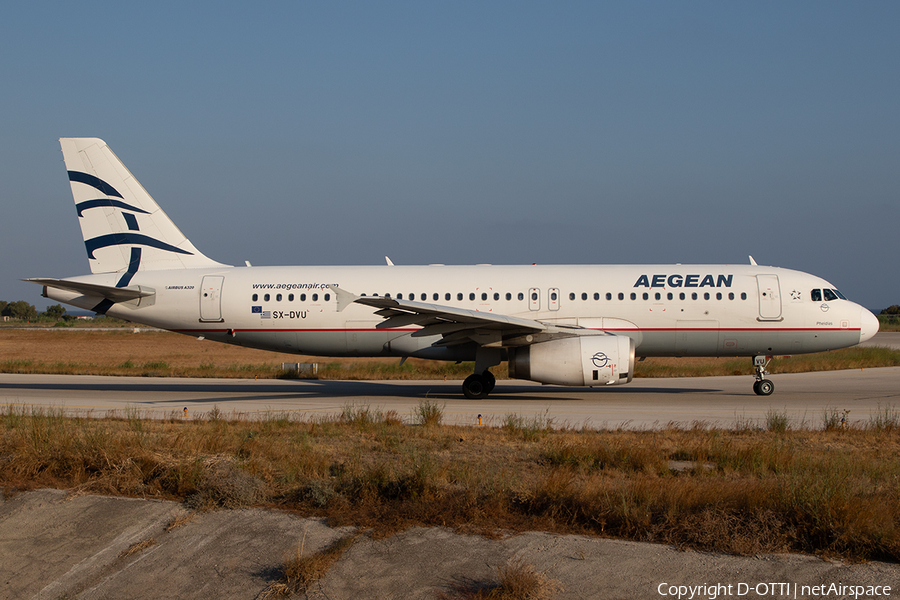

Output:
xmin=24 ymin=138 xmax=879 ymax=399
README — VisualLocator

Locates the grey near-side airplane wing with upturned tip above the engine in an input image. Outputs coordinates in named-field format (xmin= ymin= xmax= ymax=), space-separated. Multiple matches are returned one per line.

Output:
xmin=329 ymin=286 xmax=606 ymax=347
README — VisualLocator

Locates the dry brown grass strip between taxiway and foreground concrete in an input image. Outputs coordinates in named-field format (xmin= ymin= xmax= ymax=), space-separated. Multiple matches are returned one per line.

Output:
xmin=0 ymin=406 xmax=900 ymax=561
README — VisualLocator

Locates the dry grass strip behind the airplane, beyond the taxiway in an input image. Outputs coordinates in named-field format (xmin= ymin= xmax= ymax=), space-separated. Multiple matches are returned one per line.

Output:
xmin=0 ymin=328 xmax=900 ymax=380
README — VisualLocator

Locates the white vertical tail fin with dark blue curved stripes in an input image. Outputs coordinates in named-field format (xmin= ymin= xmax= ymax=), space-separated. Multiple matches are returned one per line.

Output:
xmin=59 ymin=138 xmax=223 ymax=278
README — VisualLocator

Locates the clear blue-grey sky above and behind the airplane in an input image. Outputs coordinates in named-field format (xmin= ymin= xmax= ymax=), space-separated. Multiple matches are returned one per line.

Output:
xmin=0 ymin=2 xmax=900 ymax=310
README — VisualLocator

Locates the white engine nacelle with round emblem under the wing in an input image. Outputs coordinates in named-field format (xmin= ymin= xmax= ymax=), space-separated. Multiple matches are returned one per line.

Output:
xmin=509 ymin=335 xmax=634 ymax=386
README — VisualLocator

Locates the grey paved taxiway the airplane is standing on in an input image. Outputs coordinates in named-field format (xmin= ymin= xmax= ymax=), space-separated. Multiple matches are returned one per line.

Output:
xmin=0 ymin=367 xmax=900 ymax=429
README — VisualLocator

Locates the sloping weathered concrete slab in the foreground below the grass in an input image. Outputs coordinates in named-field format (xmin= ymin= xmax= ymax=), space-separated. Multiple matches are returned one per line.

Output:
xmin=0 ymin=490 xmax=900 ymax=600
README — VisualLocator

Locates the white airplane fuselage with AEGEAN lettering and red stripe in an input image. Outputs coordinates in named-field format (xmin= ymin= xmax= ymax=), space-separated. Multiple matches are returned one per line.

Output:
xmin=47 ymin=265 xmax=877 ymax=360
